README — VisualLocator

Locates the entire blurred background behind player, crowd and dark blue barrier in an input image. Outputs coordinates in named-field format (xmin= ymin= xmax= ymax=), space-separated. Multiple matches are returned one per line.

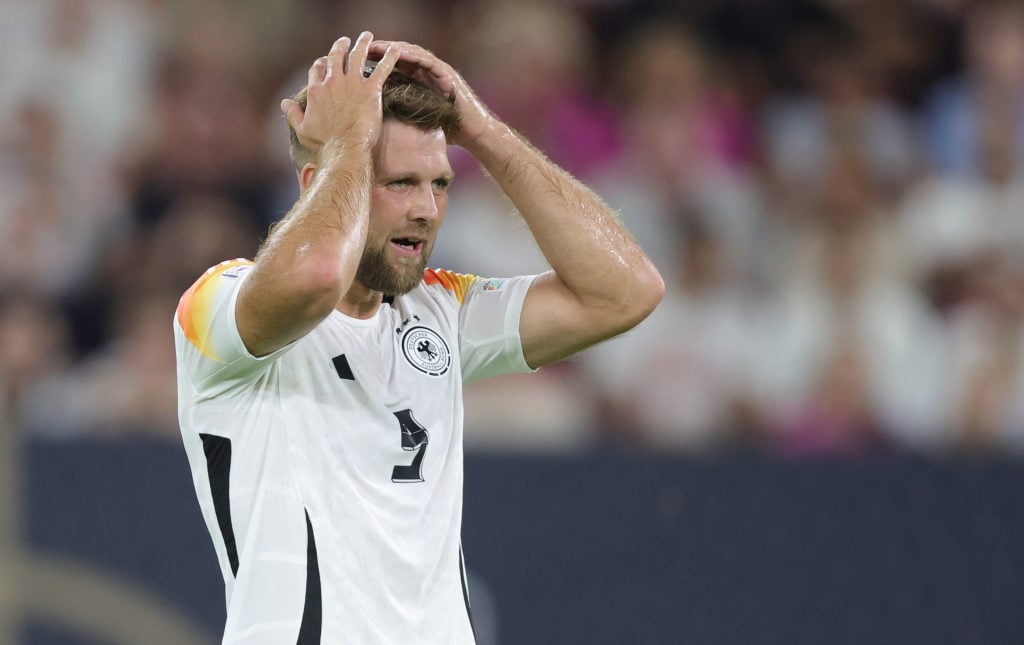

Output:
xmin=0 ymin=0 xmax=1024 ymax=645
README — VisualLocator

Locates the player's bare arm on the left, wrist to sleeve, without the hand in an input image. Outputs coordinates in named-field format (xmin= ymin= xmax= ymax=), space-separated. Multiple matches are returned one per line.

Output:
xmin=237 ymin=140 xmax=372 ymax=355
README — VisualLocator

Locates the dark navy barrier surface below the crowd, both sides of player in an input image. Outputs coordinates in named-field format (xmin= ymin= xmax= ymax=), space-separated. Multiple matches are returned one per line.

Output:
xmin=19 ymin=440 xmax=1024 ymax=645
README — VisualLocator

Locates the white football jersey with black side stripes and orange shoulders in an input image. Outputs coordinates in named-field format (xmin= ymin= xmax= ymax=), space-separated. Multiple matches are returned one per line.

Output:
xmin=174 ymin=260 xmax=534 ymax=645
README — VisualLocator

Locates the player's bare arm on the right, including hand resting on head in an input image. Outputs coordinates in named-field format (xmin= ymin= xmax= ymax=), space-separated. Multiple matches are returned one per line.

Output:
xmin=370 ymin=41 xmax=665 ymax=368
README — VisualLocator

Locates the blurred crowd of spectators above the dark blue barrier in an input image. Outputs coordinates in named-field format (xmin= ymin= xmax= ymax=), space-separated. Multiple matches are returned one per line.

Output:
xmin=0 ymin=0 xmax=1024 ymax=457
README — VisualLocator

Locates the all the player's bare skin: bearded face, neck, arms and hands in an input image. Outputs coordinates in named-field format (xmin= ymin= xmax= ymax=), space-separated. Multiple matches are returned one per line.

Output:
xmin=237 ymin=32 xmax=665 ymax=368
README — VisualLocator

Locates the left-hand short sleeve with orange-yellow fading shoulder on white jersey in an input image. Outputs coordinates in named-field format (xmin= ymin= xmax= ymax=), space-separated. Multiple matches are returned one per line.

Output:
xmin=175 ymin=259 xmax=290 ymax=385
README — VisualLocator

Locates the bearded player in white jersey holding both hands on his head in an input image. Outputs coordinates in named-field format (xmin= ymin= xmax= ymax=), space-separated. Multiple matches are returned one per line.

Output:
xmin=174 ymin=32 xmax=664 ymax=645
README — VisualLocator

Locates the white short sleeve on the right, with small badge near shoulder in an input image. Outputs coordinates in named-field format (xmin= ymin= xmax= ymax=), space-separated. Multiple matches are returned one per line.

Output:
xmin=459 ymin=275 xmax=537 ymax=383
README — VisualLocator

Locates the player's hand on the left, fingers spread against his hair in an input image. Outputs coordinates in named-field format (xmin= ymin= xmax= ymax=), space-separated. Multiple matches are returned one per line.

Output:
xmin=281 ymin=32 xmax=398 ymax=155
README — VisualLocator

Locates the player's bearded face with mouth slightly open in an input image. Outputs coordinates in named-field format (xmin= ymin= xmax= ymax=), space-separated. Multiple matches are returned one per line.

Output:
xmin=355 ymin=119 xmax=454 ymax=295
